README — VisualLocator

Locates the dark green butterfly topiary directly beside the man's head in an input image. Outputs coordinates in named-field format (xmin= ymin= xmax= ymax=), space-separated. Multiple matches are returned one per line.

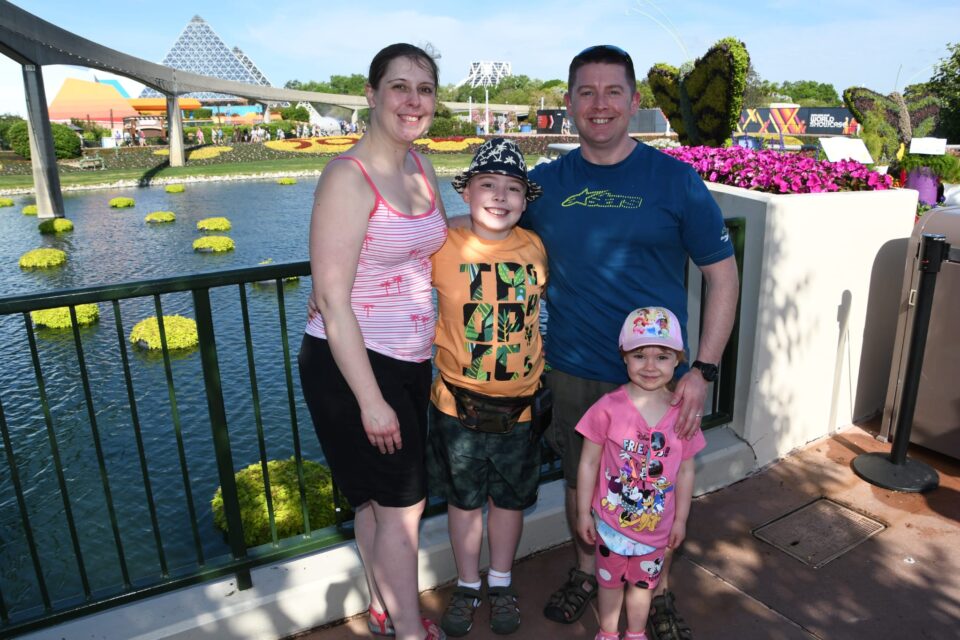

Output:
xmin=647 ymin=38 xmax=750 ymax=147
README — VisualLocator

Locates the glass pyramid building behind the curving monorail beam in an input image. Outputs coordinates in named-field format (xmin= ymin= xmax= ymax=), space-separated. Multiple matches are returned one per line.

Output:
xmin=140 ymin=16 xmax=272 ymax=102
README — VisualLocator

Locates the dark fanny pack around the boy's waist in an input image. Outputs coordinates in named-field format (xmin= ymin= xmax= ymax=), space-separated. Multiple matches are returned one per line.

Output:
xmin=441 ymin=376 xmax=553 ymax=437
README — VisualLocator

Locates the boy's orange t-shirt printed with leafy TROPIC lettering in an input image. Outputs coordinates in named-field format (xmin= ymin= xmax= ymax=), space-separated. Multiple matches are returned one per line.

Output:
xmin=431 ymin=227 xmax=547 ymax=421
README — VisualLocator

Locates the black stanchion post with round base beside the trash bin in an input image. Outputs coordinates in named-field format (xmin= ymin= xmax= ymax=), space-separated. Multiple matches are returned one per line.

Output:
xmin=853 ymin=233 xmax=950 ymax=493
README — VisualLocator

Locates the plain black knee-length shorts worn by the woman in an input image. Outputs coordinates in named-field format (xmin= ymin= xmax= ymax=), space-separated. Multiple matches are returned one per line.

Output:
xmin=298 ymin=334 xmax=432 ymax=507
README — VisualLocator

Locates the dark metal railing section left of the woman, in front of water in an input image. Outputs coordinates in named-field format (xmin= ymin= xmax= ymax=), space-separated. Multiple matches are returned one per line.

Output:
xmin=0 ymin=262 xmax=351 ymax=635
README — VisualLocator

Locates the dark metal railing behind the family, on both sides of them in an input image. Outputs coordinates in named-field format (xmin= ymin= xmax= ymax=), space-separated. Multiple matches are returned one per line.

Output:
xmin=0 ymin=219 xmax=746 ymax=636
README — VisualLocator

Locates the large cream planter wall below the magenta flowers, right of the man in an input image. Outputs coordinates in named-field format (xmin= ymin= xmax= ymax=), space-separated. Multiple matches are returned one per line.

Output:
xmin=700 ymin=183 xmax=917 ymax=472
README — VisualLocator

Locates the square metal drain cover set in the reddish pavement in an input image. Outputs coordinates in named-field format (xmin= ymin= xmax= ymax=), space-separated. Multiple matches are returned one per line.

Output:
xmin=753 ymin=498 xmax=886 ymax=569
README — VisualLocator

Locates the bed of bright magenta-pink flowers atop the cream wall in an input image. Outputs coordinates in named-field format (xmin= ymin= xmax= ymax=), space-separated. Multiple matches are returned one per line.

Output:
xmin=662 ymin=147 xmax=893 ymax=193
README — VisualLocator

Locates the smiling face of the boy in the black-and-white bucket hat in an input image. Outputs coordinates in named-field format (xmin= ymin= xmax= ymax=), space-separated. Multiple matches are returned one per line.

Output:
xmin=463 ymin=173 xmax=527 ymax=240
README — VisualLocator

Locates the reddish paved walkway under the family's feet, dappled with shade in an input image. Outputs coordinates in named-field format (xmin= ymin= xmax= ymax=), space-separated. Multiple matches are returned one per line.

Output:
xmin=298 ymin=427 xmax=960 ymax=640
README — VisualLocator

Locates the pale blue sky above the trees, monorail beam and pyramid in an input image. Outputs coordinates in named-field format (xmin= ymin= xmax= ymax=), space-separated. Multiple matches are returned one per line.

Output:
xmin=0 ymin=0 xmax=960 ymax=114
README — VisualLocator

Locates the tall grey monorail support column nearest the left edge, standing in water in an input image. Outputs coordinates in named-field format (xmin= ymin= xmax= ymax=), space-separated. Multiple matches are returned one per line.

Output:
xmin=23 ymin=64 xmax=64 ymax=218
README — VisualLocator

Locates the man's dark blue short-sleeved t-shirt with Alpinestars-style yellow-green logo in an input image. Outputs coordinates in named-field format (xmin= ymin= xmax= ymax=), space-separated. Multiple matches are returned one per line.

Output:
xmin=521 ymin=143 xmax=733 ymax=383
